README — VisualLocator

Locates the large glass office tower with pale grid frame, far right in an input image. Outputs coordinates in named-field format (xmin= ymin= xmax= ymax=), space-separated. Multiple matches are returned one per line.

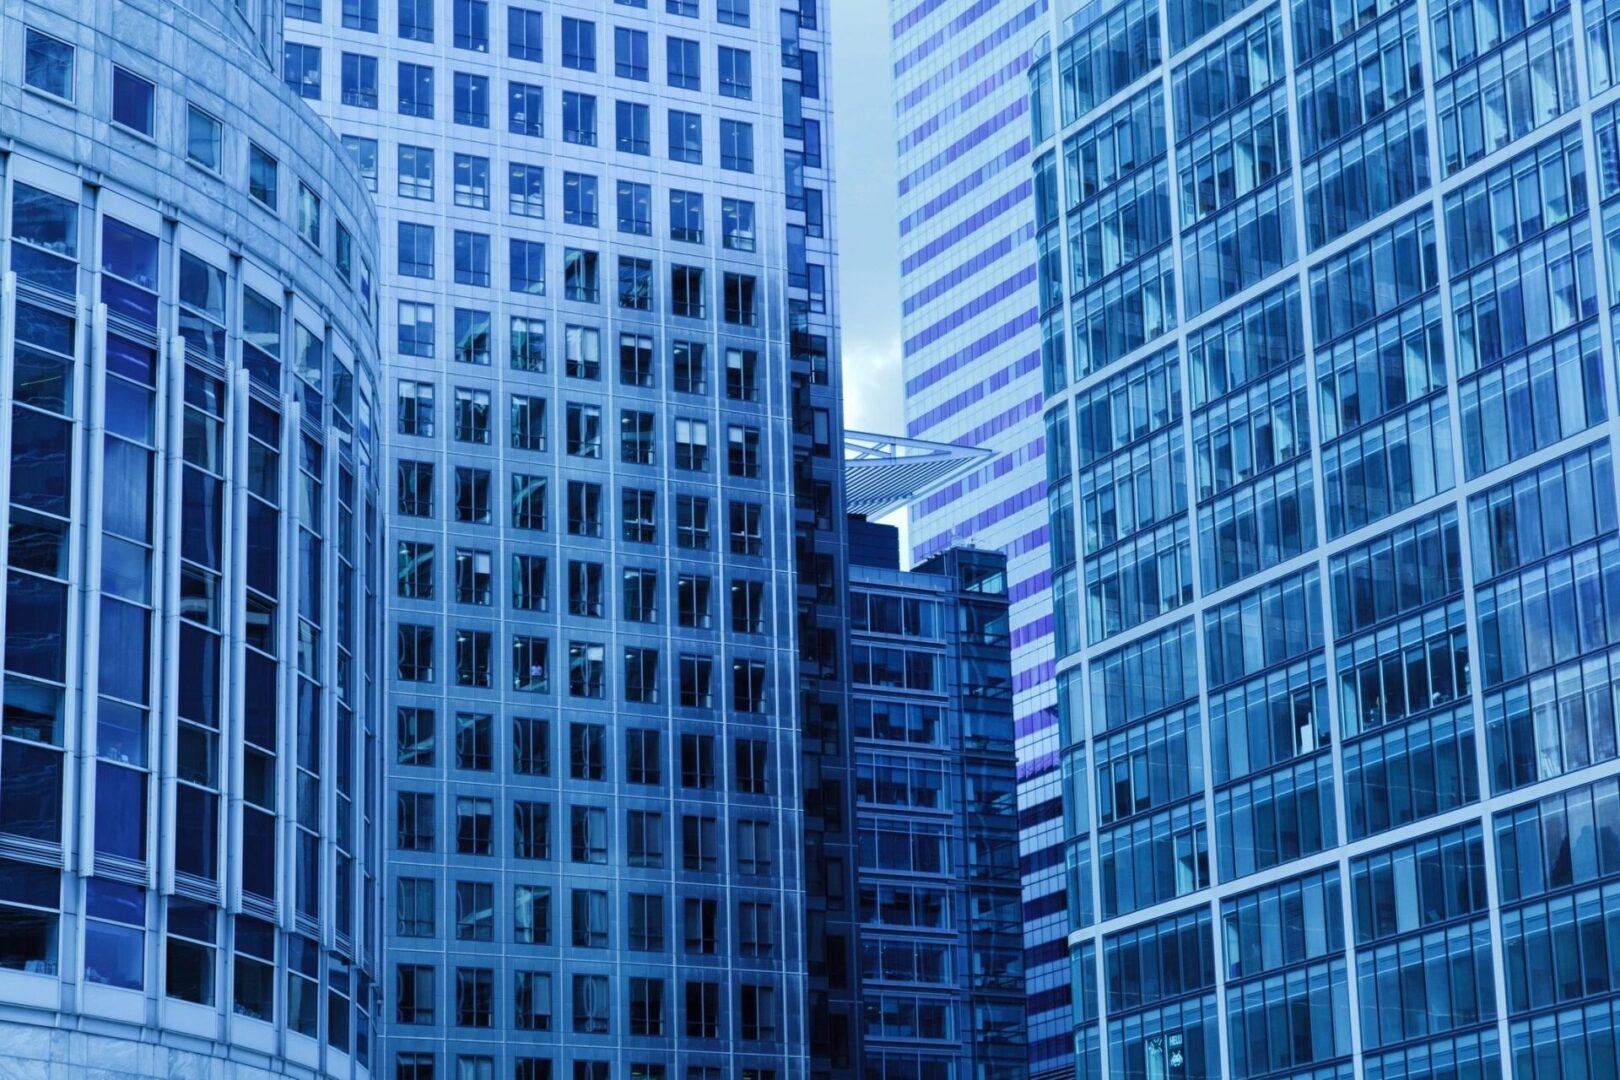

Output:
xmin=1030 ymin=0 xmax=1620 ymax=1080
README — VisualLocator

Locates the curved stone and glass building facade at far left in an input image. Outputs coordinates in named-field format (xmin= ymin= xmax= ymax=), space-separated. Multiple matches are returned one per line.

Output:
xmin=0 ymin=0 xmax=381 ymax=1077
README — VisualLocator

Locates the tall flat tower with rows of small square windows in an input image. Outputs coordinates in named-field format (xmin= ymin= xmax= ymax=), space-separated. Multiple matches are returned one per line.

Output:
xmin=282 ymin=0 xmax=854 ymax=1080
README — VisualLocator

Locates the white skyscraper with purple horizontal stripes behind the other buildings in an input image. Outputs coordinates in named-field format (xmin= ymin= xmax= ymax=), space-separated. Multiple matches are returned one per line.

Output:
xmin=889 ymin=0 xmax=1072 ymax=1074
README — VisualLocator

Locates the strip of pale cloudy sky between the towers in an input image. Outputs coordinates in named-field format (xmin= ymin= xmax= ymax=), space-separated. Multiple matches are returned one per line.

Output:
xmin=821 ymin=0 xmax=906 ymax=436
